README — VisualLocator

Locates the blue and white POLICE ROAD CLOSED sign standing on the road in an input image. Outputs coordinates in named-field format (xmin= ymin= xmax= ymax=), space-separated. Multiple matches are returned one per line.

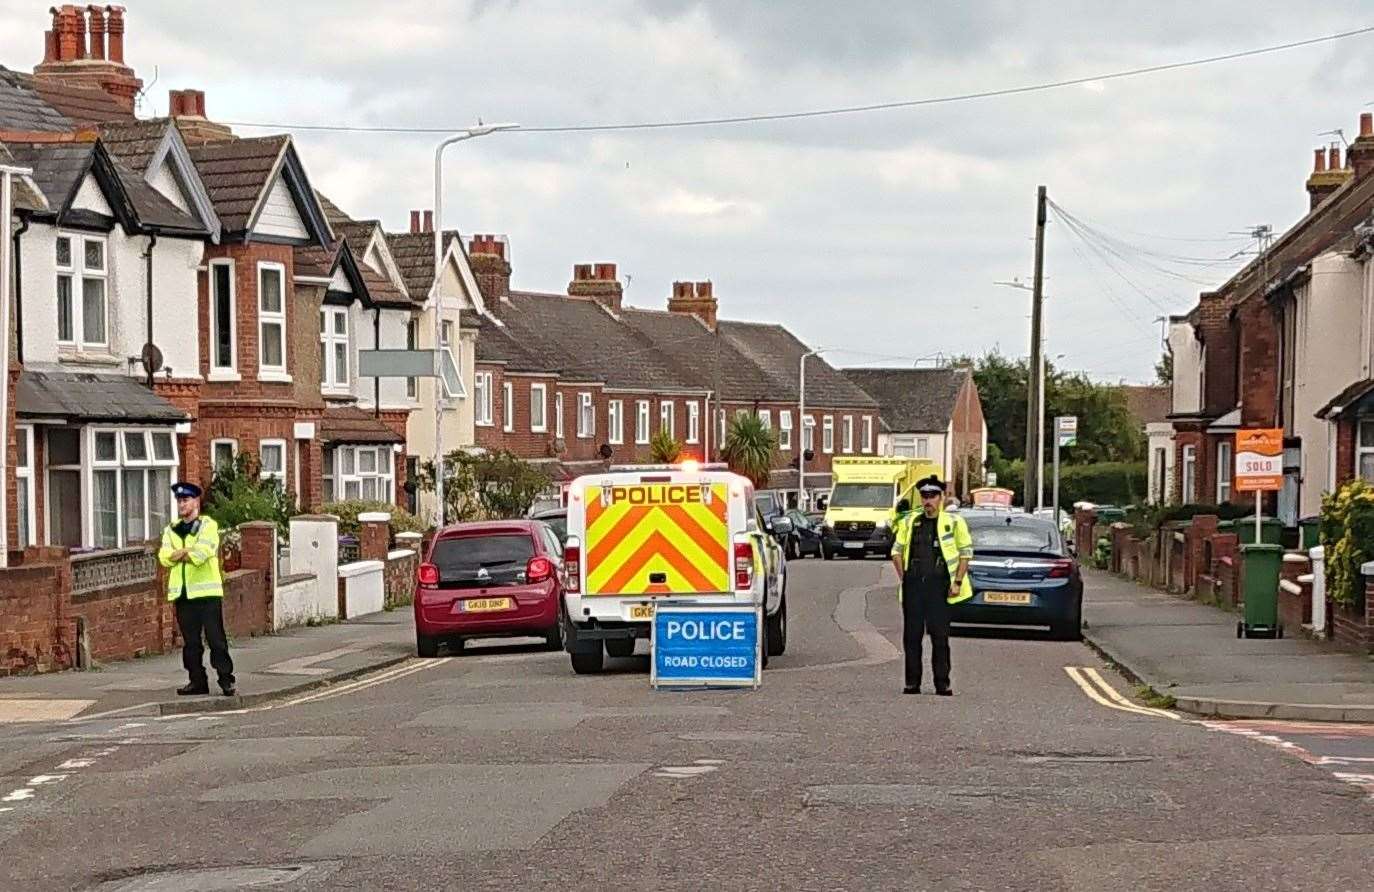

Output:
xmin=650 ymin=602 xmax=760 ymax=687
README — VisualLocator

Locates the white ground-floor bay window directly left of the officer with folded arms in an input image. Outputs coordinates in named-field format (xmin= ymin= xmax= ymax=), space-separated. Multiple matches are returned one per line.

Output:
xmin=88 ymin=429 xmax=177 ymax=548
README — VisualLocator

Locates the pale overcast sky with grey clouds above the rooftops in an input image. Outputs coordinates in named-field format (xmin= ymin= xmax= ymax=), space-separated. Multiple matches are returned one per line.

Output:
xmin=0 ymin=0 xmax=1374 ymax=381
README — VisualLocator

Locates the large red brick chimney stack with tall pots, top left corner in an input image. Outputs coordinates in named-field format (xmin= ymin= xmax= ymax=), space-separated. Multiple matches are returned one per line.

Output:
xmin=33 ymin=3 xmax=143 ymax=117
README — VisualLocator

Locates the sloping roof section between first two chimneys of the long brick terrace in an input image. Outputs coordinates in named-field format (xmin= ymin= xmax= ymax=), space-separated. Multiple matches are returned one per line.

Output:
xmin=497 ymin=291 xmax=705 ymax=390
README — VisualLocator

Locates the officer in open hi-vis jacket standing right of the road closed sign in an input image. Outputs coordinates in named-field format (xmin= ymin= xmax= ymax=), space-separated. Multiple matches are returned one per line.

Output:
xmin=892 ymin=474 xmax=973 ymax=697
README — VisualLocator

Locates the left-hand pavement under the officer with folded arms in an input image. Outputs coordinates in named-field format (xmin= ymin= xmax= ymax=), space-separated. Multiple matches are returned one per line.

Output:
xmin=0 ymin=607 xmax=415 ymax=724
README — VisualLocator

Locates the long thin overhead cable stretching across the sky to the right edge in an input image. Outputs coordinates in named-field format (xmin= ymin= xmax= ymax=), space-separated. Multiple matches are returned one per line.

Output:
xmin=225 ymin=25 xmax=1374 ymax=133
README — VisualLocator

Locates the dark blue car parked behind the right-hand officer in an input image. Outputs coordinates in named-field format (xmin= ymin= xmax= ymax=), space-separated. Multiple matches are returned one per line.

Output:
xmin=951 ymin=509 xmax=1083 ymax=640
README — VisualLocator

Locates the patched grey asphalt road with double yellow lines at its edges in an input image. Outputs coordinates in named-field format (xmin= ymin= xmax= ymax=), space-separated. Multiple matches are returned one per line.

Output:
xmin=0 ymin=561 xmax=1374 ymax=892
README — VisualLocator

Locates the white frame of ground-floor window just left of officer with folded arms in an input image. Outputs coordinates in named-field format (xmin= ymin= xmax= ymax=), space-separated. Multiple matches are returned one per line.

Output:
xmin=81 ymin=426 xmax=179 ymax=548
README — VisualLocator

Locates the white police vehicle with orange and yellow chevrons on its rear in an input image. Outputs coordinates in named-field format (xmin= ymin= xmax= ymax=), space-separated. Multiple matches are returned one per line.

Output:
xmin=562 ymin=462 xmax=787 ymax=675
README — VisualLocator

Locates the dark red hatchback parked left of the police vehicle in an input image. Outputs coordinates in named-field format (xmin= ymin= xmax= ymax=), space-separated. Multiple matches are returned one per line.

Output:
xmin=415 ymin=521 xmax=563 ymax=657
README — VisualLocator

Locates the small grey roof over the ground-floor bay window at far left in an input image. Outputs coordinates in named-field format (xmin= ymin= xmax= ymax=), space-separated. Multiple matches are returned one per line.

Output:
xmin=15 ymin=368 xmax=187 ymax=425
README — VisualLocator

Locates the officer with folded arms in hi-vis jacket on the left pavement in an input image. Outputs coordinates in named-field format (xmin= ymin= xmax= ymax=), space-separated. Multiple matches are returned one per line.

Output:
xmin=158 ymin=482 xmax=234 ymax=697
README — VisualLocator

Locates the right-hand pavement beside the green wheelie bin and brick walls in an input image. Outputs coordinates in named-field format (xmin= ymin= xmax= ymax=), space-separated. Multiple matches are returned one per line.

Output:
xmin=1083 ymin=570 xmax=1374 ymax=722
